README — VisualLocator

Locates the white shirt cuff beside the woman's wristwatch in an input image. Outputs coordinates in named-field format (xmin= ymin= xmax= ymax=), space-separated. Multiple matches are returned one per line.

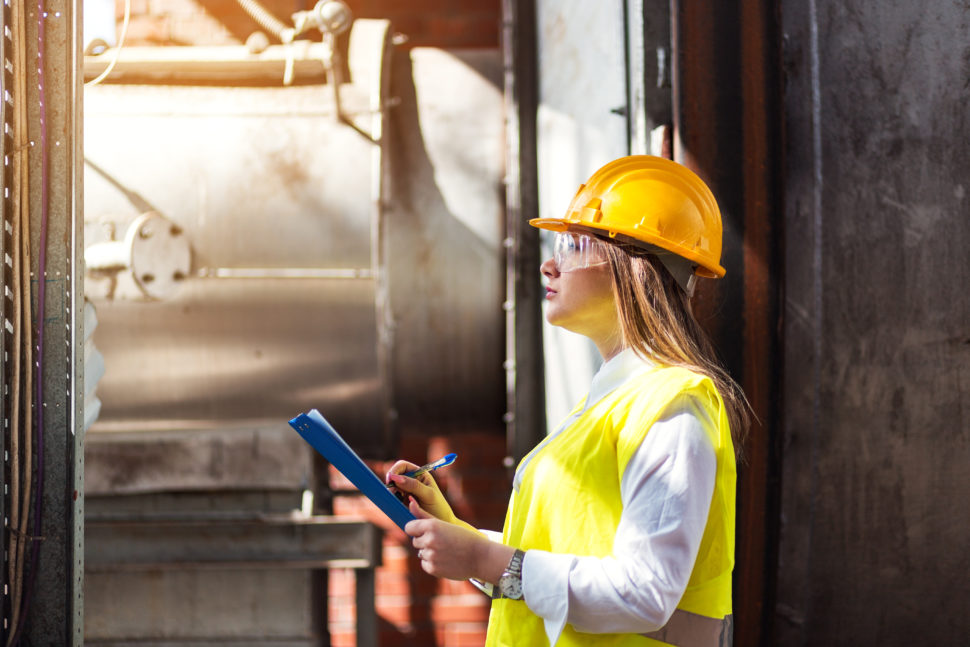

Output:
xmin=522 ymin=550 xmax=576 ymax=645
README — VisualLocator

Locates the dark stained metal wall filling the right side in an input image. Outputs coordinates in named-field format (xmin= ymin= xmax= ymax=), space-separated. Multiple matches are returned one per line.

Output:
xmin=770 ymin=0 xmax=970 ymax=646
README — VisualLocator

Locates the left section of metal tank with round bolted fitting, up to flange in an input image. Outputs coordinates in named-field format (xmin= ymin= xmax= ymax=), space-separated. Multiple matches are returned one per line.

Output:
xmin=84 ymin=21 xmax=389 ymax=452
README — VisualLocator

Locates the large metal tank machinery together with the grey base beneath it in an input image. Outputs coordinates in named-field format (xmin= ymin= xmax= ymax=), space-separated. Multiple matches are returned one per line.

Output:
xmin=83 ymin=0 xmax=505 ymax=645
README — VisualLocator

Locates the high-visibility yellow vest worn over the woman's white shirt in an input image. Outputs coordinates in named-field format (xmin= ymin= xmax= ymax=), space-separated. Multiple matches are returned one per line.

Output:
xmin=486 ymin=367 xmax=736 ymax=647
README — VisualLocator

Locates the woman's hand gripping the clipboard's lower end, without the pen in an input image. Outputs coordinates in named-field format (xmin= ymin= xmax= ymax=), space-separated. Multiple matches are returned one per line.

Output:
xmin=404 ymin=498 xmax=515 ymax=583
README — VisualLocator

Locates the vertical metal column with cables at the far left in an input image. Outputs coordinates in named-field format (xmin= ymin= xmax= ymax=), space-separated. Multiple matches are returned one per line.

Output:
xmin=23 ymin=0 xmax=84 ymax=647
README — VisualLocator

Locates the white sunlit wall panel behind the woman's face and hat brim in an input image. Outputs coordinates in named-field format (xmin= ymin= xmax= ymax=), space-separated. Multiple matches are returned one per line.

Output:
xmin=536 ymin=0 xmax=629 ymax=431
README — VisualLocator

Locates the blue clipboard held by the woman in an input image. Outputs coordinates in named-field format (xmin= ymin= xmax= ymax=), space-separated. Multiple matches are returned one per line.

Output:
xmin=290 ymin=409 xmax=415 ymax=530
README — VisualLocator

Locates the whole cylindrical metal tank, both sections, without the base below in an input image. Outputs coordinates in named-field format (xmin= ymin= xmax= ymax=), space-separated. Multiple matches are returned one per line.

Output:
xmin=84 ymin=20 xmax=506 ymax=456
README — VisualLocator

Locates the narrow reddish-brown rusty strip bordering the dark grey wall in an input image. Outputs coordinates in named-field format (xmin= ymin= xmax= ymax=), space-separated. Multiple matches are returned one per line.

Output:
xmin=735 ymin=0 xmax=783 ymax=645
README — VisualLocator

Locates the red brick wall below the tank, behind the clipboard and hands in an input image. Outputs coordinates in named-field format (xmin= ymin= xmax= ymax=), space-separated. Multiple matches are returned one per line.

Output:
xmin=329 ymin=432 xmax=511 ymax=647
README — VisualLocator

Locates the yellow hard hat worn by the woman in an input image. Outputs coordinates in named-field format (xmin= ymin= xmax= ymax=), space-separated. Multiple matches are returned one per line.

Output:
xmin=529 ymin=155 xmax=724 ymax=278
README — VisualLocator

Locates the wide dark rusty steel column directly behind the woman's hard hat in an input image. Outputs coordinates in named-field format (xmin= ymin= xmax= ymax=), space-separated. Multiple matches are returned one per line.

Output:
xmin=672 ymin=0 xmax=780 ymax=645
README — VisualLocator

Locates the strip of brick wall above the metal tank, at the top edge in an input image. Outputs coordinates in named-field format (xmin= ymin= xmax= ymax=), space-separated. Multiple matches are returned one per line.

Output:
xmin=115 ymin=0 xmax=501 ymax=49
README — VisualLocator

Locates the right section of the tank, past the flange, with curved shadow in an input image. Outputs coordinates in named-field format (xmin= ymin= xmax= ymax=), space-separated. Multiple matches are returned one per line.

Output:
xmin=385 ymin=48 xmax=505 ymax=430
